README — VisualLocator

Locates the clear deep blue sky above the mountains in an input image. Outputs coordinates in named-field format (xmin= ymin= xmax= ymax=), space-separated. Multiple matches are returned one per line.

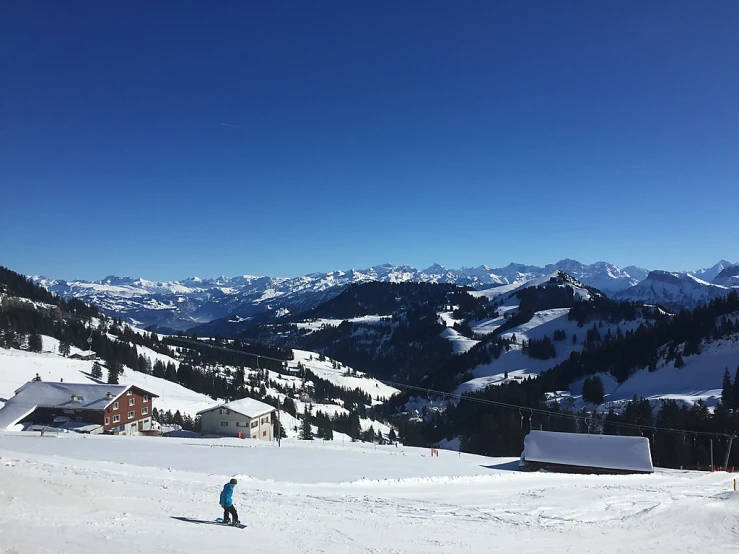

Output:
xmin=0 ymin=0 xmax=739 ymax=280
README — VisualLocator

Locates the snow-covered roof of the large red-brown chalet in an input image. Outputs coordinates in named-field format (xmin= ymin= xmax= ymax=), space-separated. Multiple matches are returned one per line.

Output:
xmin=0 ymin=381 xmax=147 ymax=429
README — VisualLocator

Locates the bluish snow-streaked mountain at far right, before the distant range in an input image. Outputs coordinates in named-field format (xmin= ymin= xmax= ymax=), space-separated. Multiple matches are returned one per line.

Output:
xmin=614 ymin=271 xmax=732 ymax=309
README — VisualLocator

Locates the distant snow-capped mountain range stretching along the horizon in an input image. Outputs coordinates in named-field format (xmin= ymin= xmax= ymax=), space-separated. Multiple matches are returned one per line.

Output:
xmin=32 ymin=259 xmax=739 ymax=330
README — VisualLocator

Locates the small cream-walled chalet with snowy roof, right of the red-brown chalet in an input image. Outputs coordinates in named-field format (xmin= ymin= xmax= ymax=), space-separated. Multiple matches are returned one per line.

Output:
xmin=198 ymin=398 xmax=276 ymax=441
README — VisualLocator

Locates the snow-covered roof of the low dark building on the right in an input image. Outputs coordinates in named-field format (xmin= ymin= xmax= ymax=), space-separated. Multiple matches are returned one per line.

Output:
xmin=522 ymin=431 xmax=654 ymax=473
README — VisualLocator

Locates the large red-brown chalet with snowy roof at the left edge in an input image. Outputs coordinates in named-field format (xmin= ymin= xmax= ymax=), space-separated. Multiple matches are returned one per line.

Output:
xmin=0 ymin=381 xmax=157 ymax=435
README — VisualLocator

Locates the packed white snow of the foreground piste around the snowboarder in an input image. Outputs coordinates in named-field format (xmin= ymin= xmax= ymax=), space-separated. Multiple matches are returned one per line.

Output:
xmin=0 ymin=433 xmax=739 ymax=554
